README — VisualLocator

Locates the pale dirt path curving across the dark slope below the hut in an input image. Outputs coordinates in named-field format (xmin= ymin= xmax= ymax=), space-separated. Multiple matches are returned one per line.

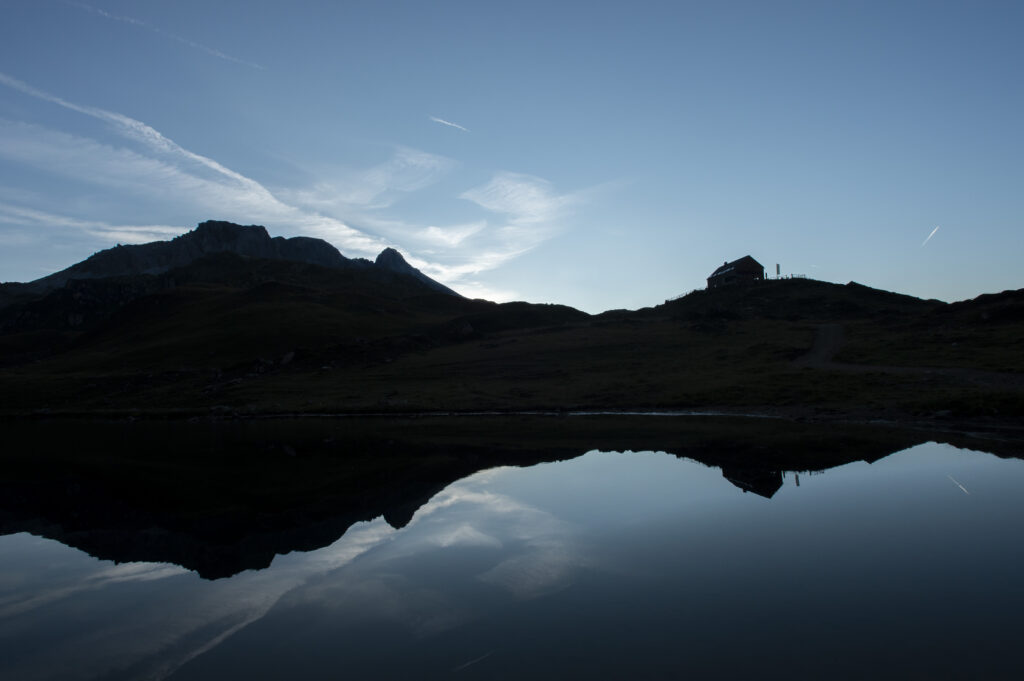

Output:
xmin=793 ymin=324 xmax=1024 ymax=390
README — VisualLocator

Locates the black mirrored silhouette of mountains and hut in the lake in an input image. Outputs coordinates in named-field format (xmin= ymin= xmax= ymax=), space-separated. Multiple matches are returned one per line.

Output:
xmin=0 ymin=417 xmax=1020 ymax=579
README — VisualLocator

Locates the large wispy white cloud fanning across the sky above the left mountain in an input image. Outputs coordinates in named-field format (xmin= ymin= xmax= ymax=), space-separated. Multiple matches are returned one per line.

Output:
xmin=0 ymin=73 xmax=586 ymax=300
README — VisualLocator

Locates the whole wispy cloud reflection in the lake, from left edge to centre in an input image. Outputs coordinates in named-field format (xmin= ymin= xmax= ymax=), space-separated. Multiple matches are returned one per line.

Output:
xmin=0 ymin=468 xmax=582 ymax=679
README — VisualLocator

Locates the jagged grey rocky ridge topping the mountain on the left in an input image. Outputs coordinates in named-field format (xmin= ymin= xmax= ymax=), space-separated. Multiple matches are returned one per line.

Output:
xmin=18 ymin=220 xmax=459 ymax=295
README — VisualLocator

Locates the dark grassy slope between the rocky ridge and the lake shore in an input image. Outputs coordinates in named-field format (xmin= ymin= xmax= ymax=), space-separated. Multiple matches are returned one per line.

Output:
xmin=0 ymin=261 xmax=1024 ymax=418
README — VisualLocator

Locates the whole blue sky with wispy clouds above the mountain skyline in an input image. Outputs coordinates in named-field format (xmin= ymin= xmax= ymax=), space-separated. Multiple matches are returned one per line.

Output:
xmin=0 ymin=0 xmax=1024 ymax=312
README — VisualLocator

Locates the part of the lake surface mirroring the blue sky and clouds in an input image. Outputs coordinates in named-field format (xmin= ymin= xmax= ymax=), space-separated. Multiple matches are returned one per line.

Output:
xmin=0 ymin=444 xmax=1024 ymax=680
